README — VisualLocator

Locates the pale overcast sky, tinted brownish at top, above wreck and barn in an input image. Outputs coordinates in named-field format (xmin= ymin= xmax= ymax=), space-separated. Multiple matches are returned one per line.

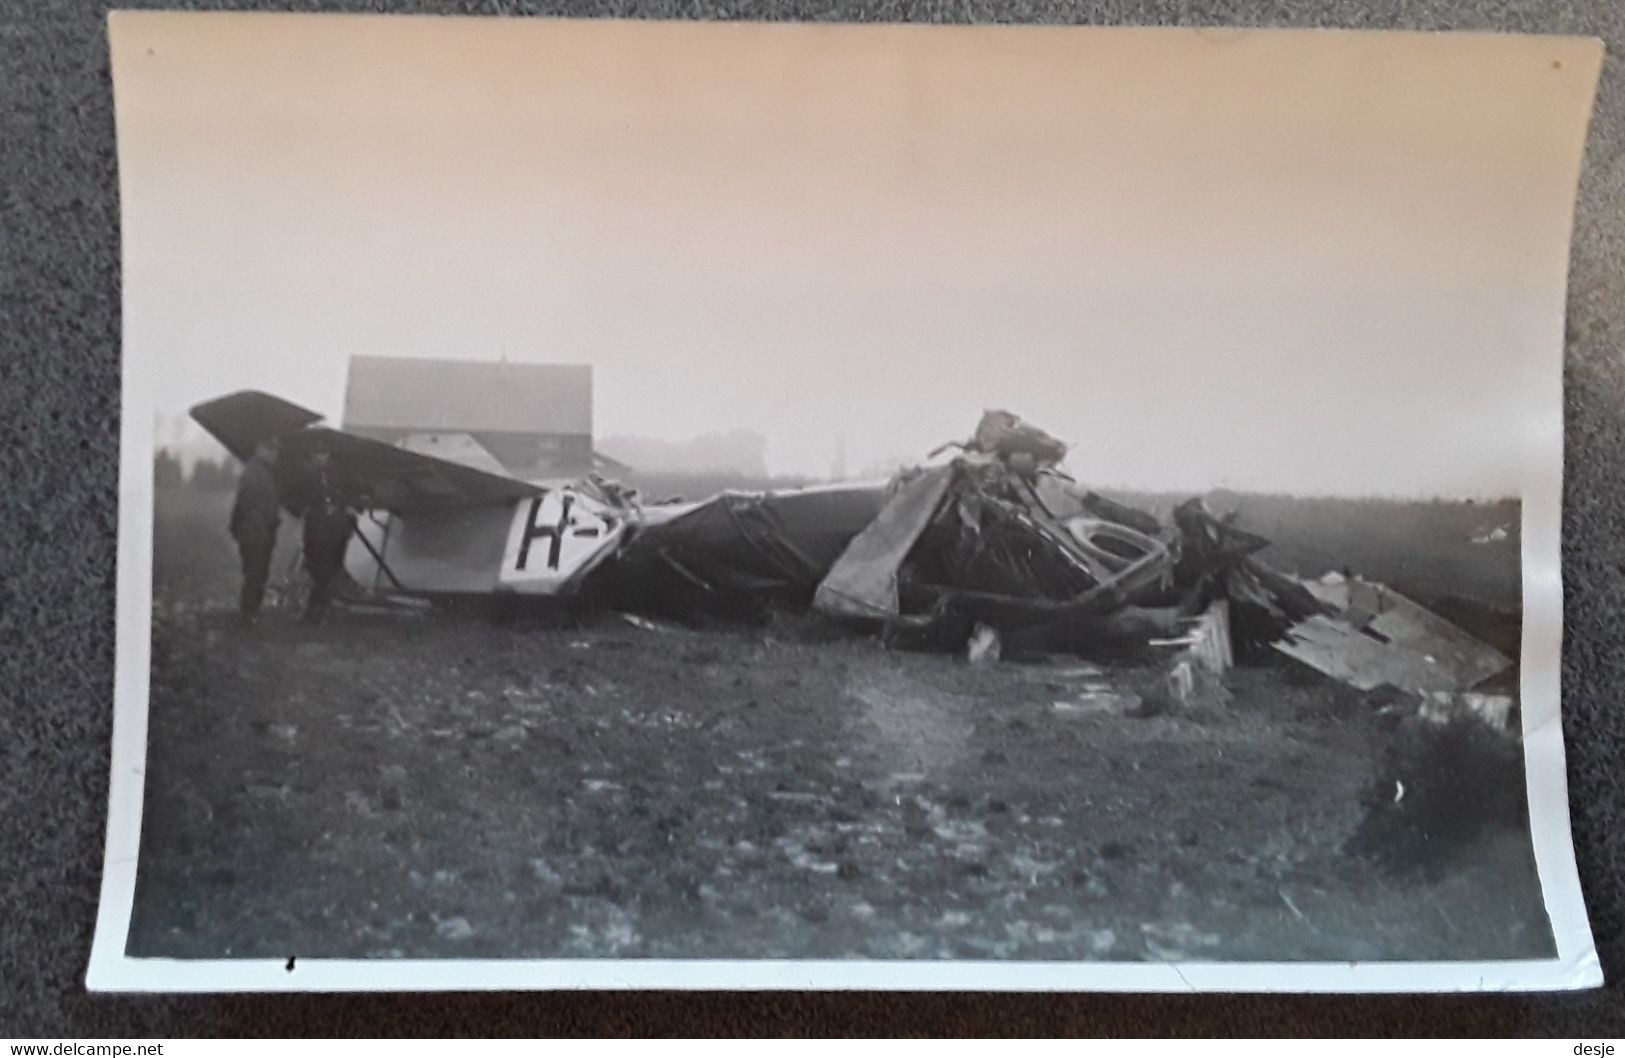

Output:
xmin=114 ymin=13 xmax=1599 ymax=496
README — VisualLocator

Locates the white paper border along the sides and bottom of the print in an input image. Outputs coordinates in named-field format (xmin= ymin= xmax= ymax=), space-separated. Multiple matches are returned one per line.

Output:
xmin=86 ymin=11 xmax=1604 ymax=993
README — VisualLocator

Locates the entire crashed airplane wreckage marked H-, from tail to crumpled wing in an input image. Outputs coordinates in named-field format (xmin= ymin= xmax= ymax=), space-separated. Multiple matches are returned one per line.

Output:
xmin=192 ymin=392 xmax=1516 ymax=733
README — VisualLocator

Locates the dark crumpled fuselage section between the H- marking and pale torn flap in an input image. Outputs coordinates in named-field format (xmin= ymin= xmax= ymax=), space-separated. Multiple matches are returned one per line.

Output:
xmin=605 ymin=484 xmax=886 ymax=613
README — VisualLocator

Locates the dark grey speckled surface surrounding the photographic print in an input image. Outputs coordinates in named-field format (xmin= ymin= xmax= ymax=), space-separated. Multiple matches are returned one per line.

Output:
xmin=0 ymin=0 xmax=1625 ymax=1053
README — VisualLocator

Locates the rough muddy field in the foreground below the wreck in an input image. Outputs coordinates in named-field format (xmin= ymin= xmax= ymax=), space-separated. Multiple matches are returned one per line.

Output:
xmin=130 ymin=494 xmax=1552 ymax=960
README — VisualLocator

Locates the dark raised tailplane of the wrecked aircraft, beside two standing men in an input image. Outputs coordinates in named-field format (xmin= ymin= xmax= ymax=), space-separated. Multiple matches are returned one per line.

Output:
xmin=192 ymin=390 xmax=540 ymax=514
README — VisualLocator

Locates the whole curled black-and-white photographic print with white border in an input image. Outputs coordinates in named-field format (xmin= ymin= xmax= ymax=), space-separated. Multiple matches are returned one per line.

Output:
xmin=89 ymin=13 xmax=1602 ymax=991
